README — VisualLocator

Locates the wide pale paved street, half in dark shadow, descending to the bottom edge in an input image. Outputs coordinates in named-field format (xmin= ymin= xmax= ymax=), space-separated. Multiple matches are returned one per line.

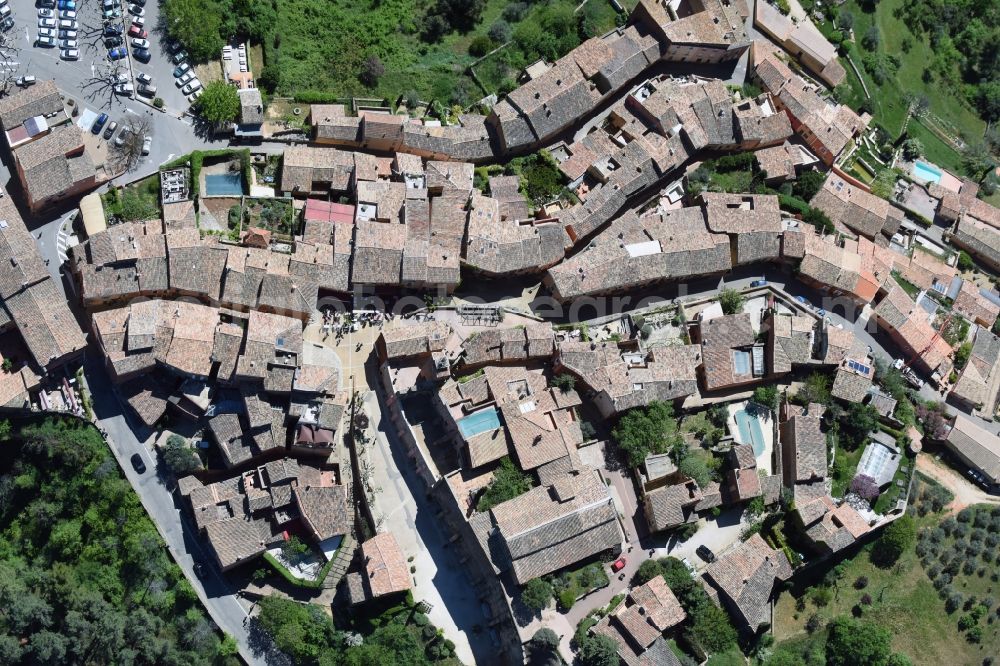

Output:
xmin=364 ymin=391 xmax=495 ymax=664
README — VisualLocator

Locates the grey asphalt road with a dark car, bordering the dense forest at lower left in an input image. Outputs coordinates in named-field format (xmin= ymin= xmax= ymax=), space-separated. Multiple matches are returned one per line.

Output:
xmin=84 ymin=355 xmax=281 ymax=666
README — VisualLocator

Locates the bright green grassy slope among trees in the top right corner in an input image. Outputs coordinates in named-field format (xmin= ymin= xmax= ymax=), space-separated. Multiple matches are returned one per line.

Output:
xmin=841 ymin=0 xmax=985 ymax=152
